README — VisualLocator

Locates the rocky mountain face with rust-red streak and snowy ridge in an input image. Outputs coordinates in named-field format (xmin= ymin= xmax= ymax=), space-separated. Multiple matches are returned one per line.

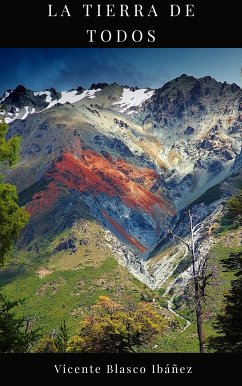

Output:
xmin=0 ymin=75 xmax=242 ymax=262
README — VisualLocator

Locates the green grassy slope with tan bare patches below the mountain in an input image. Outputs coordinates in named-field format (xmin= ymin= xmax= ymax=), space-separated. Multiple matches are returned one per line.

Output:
xmin=0 ymin=221 xmax=161 ymax=340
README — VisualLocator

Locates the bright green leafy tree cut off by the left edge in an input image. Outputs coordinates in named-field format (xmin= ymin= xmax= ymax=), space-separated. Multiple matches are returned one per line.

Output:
xmin=0 ymin=121 xmax=29 ymax=264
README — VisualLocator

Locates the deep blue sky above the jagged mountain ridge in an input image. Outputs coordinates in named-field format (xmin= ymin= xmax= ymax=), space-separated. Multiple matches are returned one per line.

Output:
xmin=0 ymin=48 xmax=242 ymax=95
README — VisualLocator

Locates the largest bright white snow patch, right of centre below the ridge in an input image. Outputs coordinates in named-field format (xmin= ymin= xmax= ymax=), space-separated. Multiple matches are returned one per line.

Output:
xmin=113 ymin=88 xmax=155 ymax=114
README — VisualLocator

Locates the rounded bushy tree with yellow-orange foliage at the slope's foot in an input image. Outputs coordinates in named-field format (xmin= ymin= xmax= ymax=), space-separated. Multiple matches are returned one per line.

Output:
xmin=68 ymin=296 xmax=165 ymax=353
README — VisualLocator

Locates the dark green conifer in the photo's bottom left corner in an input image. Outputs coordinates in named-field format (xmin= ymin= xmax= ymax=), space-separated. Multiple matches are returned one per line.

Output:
xmin=0 ymin=292 xmax=40 ymax=353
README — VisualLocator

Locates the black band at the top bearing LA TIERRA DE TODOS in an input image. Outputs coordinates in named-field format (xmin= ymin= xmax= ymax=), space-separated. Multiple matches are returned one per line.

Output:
xmin=0 ymin=0 xmax=242 ymax=48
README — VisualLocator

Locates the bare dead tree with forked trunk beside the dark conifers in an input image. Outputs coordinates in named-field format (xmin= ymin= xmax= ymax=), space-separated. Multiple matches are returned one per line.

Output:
xmin=166 ymin=210 xmax=212 ymax=353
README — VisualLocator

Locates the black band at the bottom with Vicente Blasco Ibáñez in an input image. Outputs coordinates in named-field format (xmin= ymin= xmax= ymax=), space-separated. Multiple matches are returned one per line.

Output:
xmin=0 ymin=354 xmax=242 ymax=386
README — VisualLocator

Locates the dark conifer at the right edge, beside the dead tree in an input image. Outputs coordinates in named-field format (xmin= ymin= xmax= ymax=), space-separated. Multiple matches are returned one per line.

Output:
xmin=209 ymin=252 xmax=242 ymax=352
